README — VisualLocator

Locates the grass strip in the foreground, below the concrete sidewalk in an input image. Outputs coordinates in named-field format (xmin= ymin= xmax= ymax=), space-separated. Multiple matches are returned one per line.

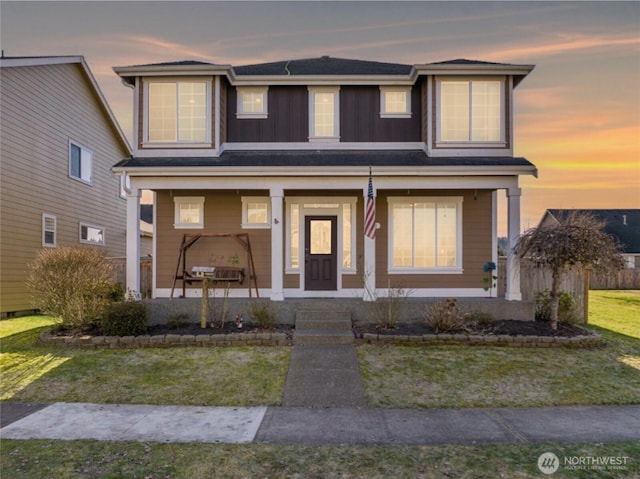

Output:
xmin=2 ymin=440 xmax=640 ymax=479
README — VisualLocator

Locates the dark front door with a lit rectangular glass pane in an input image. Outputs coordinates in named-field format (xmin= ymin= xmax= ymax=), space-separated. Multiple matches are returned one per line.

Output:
xmin=304 ymin=216 xmax=338 ymax=291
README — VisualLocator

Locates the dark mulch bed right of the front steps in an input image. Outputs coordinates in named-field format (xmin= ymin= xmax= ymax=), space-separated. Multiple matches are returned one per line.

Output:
xmin=355 ymin=319 xmax=592 ymax=338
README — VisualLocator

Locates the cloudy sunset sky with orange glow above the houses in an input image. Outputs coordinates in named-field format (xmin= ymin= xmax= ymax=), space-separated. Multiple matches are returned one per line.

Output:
xmin=0 ymin=0 xmax=640 ymax=233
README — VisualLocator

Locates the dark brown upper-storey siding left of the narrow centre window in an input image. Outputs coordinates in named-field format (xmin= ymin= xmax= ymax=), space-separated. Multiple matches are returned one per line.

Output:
xmin=226 ymin=86 xmax=309 ymax=142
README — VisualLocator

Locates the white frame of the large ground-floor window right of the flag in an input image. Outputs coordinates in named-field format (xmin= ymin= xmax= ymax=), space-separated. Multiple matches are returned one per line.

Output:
xmin=387 ymin=196 xmax=463 ymax=274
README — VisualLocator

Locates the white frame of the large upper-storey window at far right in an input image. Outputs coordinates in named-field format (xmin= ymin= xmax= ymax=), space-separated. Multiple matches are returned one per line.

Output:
xmin=436 ymin=76 xmax=507 ymax=148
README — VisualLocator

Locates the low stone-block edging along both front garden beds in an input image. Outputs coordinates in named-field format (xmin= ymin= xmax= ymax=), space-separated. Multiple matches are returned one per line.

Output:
xmin=40 ymin=330 xmax=604 ymax=349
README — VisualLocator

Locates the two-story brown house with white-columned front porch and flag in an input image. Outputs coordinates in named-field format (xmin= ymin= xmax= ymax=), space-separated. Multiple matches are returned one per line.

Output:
xmin=113 ymin=57 xmax=537 ymax=301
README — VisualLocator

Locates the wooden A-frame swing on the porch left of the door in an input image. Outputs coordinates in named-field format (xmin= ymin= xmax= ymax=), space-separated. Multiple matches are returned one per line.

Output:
xmin=171 ymin=233 xmax=260 ymax=298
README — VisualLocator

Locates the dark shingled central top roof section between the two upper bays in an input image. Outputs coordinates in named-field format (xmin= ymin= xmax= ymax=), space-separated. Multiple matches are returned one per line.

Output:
xmin=238 ymin=56 xmax=413 ymax=76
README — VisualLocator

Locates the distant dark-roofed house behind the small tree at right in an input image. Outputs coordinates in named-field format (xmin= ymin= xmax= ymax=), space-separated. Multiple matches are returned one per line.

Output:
xmin=540 ymin=209 xmax=640 ymax=269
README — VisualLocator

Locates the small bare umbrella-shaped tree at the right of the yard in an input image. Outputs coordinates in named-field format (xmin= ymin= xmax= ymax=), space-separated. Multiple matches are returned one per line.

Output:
xmin=515 ymin=211 xmax=624 ymax=329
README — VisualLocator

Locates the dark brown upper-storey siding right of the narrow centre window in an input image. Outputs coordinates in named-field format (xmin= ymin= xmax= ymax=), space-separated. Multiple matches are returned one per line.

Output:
xmin=340 ymin=86 xmax=422 ymax=142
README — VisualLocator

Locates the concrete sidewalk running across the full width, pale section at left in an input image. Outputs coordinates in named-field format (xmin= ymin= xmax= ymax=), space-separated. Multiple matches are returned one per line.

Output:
xmin=0 ymin=402 xmax=640 ymax=445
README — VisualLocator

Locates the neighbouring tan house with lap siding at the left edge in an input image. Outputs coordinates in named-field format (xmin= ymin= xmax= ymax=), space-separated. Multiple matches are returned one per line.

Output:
xmin=0 ymin=56 xmax=131 ymax=316
